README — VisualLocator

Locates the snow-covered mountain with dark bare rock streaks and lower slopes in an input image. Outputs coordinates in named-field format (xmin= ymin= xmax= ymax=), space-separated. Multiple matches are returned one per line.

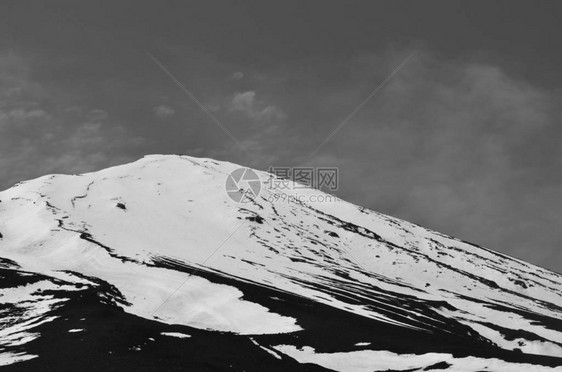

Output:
xmin=0 ymin=155 xmax=562 ymax=372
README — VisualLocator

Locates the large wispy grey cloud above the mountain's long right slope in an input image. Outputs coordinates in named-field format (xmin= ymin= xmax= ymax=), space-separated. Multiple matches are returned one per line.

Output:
xmin=298 ymin=56 xmax=562 ymax=265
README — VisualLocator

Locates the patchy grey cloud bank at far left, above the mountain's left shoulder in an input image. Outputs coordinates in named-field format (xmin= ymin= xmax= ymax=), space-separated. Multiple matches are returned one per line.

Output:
xmin=0 ymin=52 xmax=144 ymax=188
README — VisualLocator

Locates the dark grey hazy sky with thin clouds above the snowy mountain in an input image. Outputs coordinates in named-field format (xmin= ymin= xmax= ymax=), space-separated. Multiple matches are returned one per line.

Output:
xmin=0 ymin=0 xmax=562 ymax=272
